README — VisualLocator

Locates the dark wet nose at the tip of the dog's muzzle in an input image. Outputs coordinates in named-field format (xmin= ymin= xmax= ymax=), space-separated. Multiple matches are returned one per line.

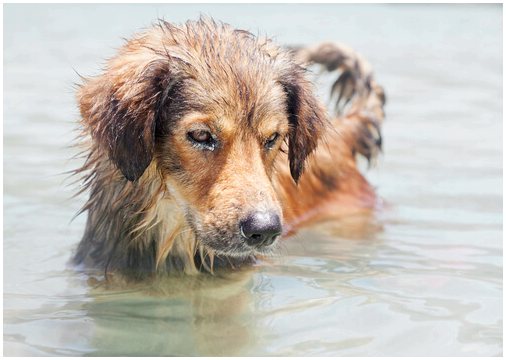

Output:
xmin=239 ymin=211 xmax=283 ymax=247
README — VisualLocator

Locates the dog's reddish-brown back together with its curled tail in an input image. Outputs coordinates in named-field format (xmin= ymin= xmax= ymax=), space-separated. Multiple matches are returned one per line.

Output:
xmin=279 ymin=42 xmax=385 ymax=233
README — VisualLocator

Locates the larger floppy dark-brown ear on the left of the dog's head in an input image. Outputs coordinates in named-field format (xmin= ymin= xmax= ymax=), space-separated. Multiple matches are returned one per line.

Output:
xmin=77 ymin=45 xmax=169 ymax=181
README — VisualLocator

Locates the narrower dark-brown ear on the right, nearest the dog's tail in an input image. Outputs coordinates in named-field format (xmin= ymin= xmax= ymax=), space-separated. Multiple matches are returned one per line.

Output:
xmin=280 ymin=66 xmax=327 ymax=182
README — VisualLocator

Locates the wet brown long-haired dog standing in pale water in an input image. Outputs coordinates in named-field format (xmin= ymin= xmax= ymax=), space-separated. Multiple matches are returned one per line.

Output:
xmin=73 ymin=18 xmax=385 ymax=278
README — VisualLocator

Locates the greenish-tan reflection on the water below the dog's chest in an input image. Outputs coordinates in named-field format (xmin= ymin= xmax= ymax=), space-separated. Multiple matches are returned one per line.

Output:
xmin=85 ymin=268 xmax=256 ymax=356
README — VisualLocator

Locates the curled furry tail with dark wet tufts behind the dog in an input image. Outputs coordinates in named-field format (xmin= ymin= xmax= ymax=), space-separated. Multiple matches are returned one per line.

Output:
xmin=289 ymin=42 xmax=386 ymax=161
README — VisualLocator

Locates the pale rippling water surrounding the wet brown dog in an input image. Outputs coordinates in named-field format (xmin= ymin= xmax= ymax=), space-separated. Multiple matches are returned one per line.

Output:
xmin=3 ymin=4 xmax=503 ymax=356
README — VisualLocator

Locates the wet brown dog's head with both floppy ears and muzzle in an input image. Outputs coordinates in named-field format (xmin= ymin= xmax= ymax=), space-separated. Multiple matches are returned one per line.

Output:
xmin=78 ymin=20 xmax=326 ymax=256
